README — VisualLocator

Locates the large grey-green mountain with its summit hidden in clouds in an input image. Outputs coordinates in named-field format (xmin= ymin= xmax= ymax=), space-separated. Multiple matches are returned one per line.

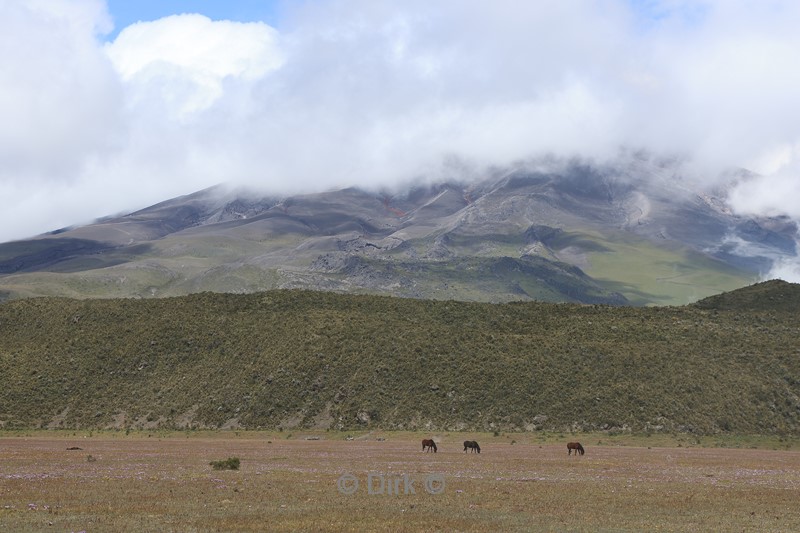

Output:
xmin=0 ymin=157 xmax=797 ymax=305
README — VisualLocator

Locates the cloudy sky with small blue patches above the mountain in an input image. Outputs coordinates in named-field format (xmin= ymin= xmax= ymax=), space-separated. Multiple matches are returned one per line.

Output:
xmin=0 ymin=0 xmax=800 ymax=264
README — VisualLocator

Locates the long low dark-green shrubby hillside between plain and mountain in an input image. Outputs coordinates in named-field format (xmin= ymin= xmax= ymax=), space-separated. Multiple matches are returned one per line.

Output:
xmin=0 ymin=282 xmax=800 ymax=434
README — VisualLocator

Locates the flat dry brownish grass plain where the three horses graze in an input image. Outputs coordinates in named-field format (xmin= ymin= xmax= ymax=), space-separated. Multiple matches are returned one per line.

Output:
xmin=0 ymin=432 xmax=800 ymax=532
